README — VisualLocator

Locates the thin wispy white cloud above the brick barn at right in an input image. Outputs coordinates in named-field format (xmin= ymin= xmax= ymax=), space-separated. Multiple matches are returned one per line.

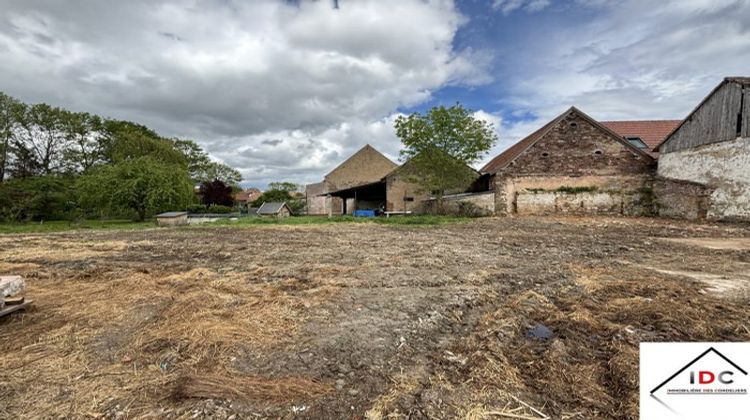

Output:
xmin=496 ymin=0 xmax=750 ymax=145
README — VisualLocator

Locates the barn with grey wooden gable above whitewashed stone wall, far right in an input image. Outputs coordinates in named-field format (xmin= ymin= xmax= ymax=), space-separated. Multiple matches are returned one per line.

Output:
xmin=655 ymin=77 xmax=750 ymax=220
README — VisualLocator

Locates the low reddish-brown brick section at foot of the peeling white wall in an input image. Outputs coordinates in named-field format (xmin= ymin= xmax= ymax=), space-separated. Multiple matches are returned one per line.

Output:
xmin=654 ymin=177 xmax=713 ymax=220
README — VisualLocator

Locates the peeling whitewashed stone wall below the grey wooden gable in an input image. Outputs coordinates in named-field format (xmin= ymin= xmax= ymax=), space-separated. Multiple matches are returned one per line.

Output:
xmin=658 ymin=138 xmax=750 ymax=220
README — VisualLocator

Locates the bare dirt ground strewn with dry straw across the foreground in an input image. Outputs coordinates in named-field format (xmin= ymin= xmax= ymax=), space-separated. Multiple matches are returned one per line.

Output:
xmin=0 ymin=218 xmax=750 ymax=419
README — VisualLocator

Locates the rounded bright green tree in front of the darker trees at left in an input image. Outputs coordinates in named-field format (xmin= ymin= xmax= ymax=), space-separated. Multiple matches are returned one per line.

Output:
xmin=77 ymin=156 xmax=195 ymax=221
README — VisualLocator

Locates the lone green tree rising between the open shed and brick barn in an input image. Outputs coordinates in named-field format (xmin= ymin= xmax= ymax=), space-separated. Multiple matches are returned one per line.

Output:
xmin=395 ymin=104 xmax=497 ymax=203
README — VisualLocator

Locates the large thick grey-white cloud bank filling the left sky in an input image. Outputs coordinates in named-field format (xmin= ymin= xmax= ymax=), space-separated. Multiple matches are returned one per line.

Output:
xmin=0 ymin=0 xmax=491 ymax=187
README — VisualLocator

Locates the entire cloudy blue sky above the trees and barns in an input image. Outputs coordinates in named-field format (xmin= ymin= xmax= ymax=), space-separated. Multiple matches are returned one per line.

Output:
xmin=0 ymin=0 xmax=750 ymax=188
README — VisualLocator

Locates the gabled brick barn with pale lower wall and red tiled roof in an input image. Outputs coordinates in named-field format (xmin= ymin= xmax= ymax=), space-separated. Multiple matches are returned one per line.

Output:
xmin=481 ymin=107 xmax=667 ymax=215
